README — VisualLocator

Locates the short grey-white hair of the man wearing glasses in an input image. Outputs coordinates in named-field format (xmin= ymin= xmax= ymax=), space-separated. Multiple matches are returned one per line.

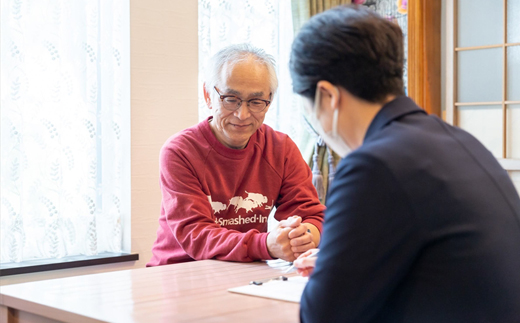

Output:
xmin=205 ymin=44 xmax=278 ymax=96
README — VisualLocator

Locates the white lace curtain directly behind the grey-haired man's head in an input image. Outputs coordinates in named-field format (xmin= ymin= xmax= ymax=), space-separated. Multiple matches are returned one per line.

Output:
xmin=199 ymin=0 xmax=304 ymax=144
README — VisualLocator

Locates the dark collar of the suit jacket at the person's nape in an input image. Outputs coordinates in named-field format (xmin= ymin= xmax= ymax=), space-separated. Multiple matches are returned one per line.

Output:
xmin=363 ymin=96 xmax=426 ymax=142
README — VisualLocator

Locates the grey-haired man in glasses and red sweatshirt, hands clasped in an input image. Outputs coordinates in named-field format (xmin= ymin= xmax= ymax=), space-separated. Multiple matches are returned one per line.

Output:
xmin=147 ymin=45 xmax=324 ymax=266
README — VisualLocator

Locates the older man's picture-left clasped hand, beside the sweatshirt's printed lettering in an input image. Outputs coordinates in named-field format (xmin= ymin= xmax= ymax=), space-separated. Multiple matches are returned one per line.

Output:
xmin=267 ymin=216 xmax=300 ymax=261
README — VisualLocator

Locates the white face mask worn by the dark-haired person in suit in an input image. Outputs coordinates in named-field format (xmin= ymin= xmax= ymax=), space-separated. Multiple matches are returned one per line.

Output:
xmin=309 ymin=88 xmax=350 ymax=158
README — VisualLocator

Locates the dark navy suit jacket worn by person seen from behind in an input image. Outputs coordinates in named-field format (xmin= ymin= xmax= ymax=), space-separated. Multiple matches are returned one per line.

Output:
xmin=300 ymin=97 xmax=520 ymax=323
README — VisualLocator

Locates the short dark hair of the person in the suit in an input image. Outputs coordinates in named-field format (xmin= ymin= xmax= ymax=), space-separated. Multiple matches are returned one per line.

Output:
xmin=290 ymin=5 xmax=404 ymax=103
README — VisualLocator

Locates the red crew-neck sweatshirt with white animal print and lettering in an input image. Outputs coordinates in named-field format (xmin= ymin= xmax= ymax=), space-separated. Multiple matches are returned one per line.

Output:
xmin=147 ymin=117 xmax=325 ymax=266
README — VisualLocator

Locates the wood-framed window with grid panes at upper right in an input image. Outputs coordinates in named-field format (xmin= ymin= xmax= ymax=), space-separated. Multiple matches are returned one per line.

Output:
xmin=446 ymin=0 xmax=520 ymax=191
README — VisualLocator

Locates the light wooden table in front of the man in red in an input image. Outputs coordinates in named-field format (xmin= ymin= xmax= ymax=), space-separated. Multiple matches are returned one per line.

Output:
xmin=0 ymin=260 xmax=299 ymax=323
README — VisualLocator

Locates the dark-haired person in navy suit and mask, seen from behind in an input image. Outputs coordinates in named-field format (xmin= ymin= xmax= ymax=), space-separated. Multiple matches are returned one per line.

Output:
xmin=290 ymin=6 xmax=520 ymax=323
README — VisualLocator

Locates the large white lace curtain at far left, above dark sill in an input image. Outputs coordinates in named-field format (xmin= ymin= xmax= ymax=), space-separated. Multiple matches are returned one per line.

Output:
xmin=0 ymin=0 xmax=130 ymax=263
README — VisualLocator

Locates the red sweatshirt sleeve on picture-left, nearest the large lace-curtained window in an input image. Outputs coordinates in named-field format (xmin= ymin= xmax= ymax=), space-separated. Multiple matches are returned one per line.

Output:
xmin=160 ymin=146 xmax=272 ymax=262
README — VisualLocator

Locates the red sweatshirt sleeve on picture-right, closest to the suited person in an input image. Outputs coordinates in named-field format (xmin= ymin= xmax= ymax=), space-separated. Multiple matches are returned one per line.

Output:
xmin=275 ymin=137 xmax=325 ymax=233
